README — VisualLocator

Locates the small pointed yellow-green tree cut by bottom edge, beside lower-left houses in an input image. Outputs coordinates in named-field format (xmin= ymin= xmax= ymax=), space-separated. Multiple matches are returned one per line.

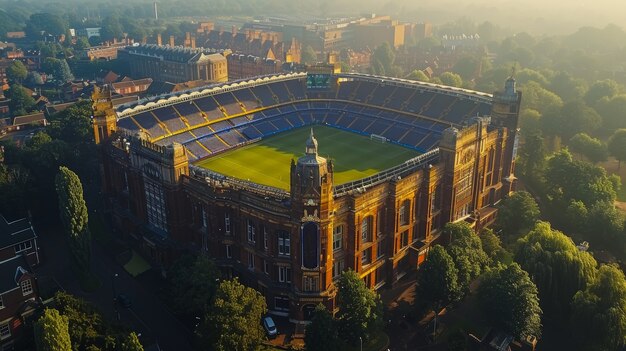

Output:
xmin=34 ymin=308 xmax=72 ymax=351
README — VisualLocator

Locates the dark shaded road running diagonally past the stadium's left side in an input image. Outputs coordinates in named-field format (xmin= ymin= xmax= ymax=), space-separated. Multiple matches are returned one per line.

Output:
xmin=35 ymin=224 xmax=192 ymax=350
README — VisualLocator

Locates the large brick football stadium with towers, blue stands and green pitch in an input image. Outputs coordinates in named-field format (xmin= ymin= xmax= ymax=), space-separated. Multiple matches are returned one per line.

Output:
xmin=93 ymin=65 xmax=521 ymax=322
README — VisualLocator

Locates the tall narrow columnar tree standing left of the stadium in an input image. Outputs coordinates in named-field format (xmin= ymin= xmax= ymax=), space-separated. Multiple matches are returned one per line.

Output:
xmin=55 ymin=167 xmax=91 ymax=275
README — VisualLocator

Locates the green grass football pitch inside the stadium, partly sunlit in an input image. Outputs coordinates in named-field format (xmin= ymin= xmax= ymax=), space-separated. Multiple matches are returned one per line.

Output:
xmin=196 ymin=126 xmax=420 ymax=190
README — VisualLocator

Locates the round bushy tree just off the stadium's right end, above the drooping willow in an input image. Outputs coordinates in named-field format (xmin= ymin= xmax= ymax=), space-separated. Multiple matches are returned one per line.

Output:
xmin=496 ymin=191 xmax=540 ymax=235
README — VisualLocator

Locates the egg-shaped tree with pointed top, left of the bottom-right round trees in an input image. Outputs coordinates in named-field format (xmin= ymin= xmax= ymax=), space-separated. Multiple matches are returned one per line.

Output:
xmin=417 ymin=245 xmax=460 ymax=310
